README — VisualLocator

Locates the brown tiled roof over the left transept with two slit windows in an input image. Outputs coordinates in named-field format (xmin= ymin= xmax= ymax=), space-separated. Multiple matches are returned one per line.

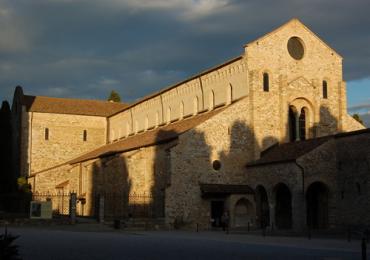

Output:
xmin=21 ymin=95 xmax=128 ymax=117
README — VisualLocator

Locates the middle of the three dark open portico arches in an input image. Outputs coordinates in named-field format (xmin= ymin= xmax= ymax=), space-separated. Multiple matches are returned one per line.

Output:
xmin=275 ymin=183 xmax=292 ymax=229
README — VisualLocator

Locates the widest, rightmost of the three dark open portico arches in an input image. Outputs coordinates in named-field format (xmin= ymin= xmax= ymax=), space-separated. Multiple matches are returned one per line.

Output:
xmin=306 ymin=182 xmax=329 ymax=229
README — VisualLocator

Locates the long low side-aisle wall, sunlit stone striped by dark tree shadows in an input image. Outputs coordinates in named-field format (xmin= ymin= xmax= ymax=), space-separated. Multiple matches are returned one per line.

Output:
xmin=29 ymin=142 xmax=173 ymax=217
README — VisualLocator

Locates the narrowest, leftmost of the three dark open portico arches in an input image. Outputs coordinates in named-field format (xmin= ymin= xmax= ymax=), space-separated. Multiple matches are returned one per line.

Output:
xmin=256 ymin=185 xmax=270 ymax=228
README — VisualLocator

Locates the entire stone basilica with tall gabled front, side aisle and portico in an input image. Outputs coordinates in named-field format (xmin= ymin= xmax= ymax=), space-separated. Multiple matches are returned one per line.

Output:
xmin=12 ymin=19 xmax=370 ymax=230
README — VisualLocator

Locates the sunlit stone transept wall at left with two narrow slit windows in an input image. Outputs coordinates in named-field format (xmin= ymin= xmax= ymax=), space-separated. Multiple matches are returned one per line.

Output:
xmin=21 ymin=110 xmax=106 ymax=176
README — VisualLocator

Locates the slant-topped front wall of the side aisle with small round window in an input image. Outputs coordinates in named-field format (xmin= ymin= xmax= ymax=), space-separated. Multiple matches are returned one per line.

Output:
xmin=166 ymin=98 xmax=254 ymax=228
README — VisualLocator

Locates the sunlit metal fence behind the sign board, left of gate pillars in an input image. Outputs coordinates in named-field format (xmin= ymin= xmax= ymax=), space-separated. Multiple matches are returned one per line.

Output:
xmin=32 ymin=192 xmax=71 ymax=215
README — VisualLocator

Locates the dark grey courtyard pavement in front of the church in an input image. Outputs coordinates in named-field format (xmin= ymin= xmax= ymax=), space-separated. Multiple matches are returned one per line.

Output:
xmin=2 ymin=224 xmax=370 ymax=260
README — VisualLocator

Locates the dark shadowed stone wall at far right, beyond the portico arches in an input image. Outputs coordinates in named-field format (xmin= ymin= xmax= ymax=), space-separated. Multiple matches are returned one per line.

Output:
xmin=335 ymin=133 xmax=370 ymax=228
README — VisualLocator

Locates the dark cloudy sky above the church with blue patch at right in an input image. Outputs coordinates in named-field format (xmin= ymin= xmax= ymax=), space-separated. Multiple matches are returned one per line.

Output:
xmin=0 ymin=0 xmax=370 ymax=116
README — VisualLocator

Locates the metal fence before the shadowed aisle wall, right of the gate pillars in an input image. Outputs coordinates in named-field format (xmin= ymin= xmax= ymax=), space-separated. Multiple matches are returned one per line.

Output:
xmin=95 ymin=193 xmax=164 ymax=218
